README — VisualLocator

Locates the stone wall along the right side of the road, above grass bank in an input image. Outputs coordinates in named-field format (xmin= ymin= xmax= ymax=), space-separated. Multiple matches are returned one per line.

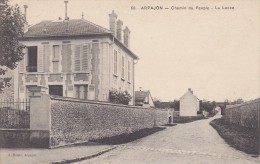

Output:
xmin=222 ymin=98 xmax=260 ymax=129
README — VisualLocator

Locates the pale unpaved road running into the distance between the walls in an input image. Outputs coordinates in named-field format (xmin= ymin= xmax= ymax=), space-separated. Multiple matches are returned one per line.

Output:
xmin=77 ymin=115 xmax=260 ymax=164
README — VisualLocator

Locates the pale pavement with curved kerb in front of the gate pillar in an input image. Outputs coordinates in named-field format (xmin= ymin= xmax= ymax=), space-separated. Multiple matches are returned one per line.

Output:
xmin=0 ymin=143 xmax=116 ymax=164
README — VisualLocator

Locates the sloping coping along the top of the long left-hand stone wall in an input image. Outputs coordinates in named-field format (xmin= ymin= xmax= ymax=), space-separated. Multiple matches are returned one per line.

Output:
xmin=49 ymin=95 xmax=167 ymax=111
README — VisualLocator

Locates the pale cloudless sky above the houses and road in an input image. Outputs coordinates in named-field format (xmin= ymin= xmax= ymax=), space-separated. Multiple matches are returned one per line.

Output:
xmin=9 ymin=0 xmax=260 ymax=101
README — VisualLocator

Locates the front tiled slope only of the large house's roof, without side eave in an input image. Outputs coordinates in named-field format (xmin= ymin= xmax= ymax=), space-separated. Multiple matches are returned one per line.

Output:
xmin=24 ymin=19 xmax=110 ymax=37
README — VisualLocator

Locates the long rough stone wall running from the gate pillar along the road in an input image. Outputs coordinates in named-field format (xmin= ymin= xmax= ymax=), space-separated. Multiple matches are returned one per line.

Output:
xmin=50 ymin=96 xmax=168 ymax=147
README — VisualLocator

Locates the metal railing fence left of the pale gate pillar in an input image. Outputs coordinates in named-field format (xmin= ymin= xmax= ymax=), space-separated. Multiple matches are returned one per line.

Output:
xmin=0 ymin=100 xmax=30 ymax=129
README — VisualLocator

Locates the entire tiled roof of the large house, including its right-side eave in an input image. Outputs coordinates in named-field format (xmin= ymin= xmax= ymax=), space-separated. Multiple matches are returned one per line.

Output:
xmin=20 ymin=19 xmax=139 ymax=59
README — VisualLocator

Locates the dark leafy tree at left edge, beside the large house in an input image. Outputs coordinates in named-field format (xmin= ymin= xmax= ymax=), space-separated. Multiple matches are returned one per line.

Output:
xmin=0 ymin=0 xmax=25 ymax=91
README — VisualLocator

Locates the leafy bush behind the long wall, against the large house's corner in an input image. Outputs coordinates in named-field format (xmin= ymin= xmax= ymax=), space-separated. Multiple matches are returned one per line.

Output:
xmin=109 ymin=90 xmax=132 ymax=105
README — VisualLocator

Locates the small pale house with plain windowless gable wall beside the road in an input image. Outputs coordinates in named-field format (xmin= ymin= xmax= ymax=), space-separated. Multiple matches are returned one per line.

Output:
xmin=180 ymin=89 xmax=200 ymax=116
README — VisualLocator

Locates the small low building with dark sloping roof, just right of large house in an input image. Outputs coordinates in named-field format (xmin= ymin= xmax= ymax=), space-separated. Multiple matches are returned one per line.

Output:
xmin=135 ymin=91 xmax=155 ymax=108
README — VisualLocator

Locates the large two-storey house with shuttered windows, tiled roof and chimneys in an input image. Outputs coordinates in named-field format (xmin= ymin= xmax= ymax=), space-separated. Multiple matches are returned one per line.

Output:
xmin=14 ymin=11 xmax=138 ymax=105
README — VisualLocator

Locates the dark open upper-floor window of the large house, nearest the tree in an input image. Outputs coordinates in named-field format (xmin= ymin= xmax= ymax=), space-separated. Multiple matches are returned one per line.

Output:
xmin=26 ymin=46 xmax=37 ymax=72
